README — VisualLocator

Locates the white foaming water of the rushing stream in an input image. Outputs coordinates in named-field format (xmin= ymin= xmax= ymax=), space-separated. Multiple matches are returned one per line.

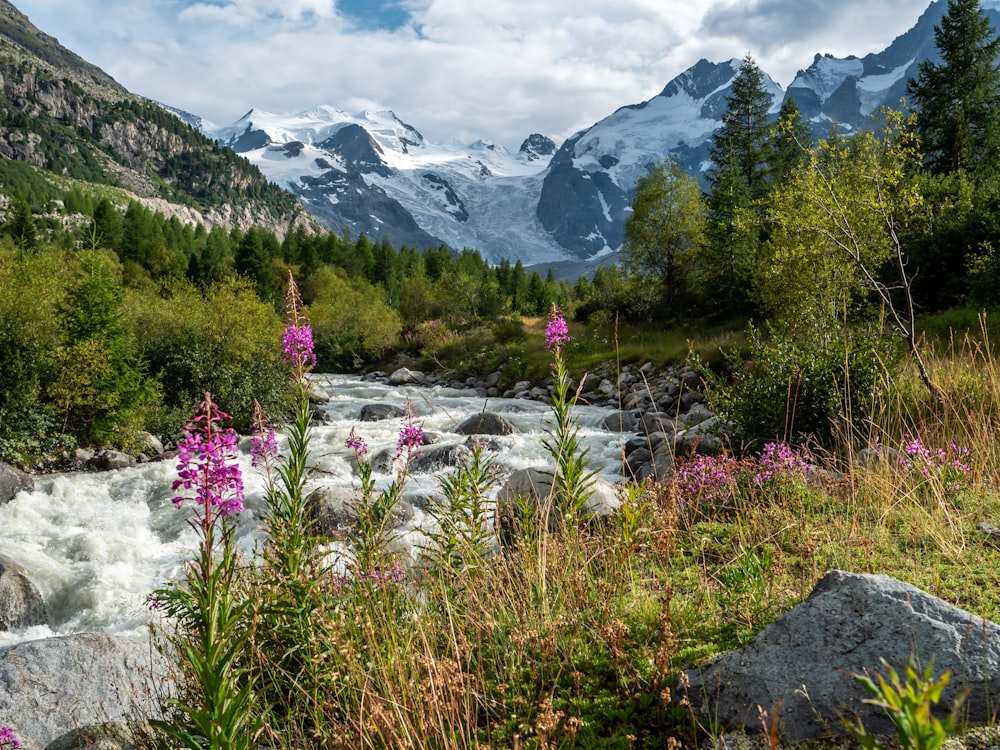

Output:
xmin=0 ymin=375 xmax=621 ymax=647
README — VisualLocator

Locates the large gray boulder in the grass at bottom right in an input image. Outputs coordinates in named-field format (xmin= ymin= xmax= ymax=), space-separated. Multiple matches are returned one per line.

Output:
xmin=687 ymin=570 xmax=1000 ymax=742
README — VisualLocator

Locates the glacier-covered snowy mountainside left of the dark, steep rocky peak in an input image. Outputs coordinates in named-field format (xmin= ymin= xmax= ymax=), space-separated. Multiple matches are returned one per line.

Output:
xmin=212 ymin=106 xmax=564 ymax=262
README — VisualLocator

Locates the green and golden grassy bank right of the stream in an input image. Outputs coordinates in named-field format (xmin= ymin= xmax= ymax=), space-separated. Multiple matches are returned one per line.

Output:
xmin=148 ymin=314 xmax=1000 ymax=749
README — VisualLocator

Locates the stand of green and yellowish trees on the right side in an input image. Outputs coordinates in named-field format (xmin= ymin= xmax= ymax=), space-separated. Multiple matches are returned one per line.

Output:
xmin=620 ymin=0 xmax=1000 ymax=328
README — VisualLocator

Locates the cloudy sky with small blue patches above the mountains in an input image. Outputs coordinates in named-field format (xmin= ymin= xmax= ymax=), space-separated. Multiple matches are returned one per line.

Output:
xmin=12 ymin=0 xmax=930 ymax=150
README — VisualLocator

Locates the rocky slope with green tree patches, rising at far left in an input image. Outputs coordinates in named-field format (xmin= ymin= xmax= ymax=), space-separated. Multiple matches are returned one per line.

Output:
xmin=0 ymin=0 xmax=304 ymax=232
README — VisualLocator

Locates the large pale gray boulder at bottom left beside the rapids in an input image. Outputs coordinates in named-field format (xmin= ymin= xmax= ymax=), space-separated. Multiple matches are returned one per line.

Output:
xmin=0 ymin=633 xmax=171 ymax=750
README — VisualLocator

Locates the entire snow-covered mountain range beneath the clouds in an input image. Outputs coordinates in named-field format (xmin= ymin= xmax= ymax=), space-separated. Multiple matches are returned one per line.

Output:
xmin=205 ymin=0 xmax=1000 ymax=265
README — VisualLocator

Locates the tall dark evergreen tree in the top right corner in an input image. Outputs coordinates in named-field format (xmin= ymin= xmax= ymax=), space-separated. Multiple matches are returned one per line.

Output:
xmin=907 ymin=0 xmax=1000 ymax=181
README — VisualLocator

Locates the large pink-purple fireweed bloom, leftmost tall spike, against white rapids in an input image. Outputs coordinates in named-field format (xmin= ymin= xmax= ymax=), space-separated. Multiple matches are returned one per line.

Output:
xmin=171 ymin=393 xmax=243 ymax=518
